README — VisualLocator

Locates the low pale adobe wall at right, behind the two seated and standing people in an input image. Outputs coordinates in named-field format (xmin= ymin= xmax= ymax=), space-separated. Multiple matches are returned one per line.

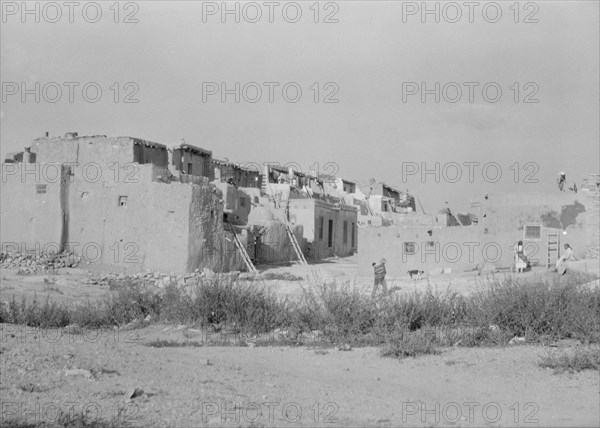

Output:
xmin=359 ymin=191 xmax=598 ymax=276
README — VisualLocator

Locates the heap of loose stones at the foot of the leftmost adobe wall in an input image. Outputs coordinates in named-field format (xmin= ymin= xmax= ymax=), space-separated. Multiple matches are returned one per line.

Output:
xmin=0 ymin=253 xmax=81 ymax=275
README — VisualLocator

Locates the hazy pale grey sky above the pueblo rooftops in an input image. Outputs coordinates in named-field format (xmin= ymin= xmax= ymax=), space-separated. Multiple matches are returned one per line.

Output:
xmin=0 ymin=1 xmax=600 ymax=211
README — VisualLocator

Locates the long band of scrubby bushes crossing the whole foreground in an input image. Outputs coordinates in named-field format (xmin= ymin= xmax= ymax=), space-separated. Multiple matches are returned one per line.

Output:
xmin=0 ymin=274 xmax=600 ymax=356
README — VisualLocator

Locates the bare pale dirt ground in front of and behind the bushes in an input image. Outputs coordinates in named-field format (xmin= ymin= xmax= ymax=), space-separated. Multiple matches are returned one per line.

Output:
xmin=0 ymin=260 xmax=600 ymax=427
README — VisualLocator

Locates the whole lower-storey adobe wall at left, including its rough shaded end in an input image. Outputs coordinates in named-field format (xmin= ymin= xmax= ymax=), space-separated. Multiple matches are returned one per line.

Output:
xmin=1 ymin=160 xmax=252 ymax=273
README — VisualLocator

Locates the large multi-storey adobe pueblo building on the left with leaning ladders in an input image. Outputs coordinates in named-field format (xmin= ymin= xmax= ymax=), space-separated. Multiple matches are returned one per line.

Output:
xmin=1 ymin=133 xmax=357 ymax=273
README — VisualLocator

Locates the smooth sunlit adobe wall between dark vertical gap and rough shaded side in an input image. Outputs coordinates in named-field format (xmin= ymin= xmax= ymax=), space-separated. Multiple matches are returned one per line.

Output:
xmin=69 ymin=165 xmax=193 ymax=273
